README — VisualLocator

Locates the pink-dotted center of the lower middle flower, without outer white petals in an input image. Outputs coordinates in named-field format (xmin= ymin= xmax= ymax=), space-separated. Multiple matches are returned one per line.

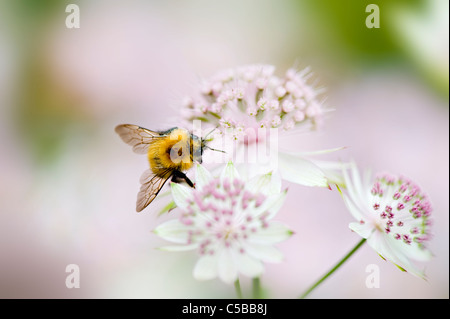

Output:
xmin=181 ymin=179 xmax=267 ymax=255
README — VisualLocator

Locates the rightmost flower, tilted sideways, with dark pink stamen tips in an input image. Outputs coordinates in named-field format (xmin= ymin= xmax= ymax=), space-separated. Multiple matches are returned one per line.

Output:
xmin=344 ymin=165 xmax=431 ymax=278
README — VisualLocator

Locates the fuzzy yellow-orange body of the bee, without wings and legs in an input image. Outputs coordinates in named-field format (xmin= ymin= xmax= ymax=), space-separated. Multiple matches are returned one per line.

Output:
xmin=148 ymin=128 xmax=193 ymax=177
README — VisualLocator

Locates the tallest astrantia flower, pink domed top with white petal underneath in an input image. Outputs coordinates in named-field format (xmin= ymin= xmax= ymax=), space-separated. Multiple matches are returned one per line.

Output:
xmin=182 ymin=64 xmax=342 ymax=187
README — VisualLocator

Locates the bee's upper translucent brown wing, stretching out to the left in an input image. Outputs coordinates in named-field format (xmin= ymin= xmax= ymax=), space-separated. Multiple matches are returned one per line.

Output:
xmin=115 ymin=124 xmax=161 ymax=154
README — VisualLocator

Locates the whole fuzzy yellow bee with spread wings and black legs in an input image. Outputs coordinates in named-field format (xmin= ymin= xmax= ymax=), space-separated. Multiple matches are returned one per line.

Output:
xmin=115 ymin=124 xmax=216 ymax=212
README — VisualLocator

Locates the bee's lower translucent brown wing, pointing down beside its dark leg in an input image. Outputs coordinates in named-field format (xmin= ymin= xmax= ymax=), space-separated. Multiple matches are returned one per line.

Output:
xmin=136 ymin=169 xmax=172 ymax=212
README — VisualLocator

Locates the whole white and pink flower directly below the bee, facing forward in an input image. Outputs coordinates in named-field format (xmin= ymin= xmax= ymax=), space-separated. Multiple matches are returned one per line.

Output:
xmin=155 ymin=163 xmax=292 ymax=283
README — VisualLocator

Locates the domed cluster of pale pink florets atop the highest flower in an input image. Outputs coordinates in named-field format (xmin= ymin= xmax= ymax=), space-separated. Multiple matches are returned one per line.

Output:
xmin=181 ymin=64 xmax=323 ymax=134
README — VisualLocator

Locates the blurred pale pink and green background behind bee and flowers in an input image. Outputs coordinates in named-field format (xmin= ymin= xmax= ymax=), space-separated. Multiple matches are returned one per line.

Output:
xmin=0 ymin=0 xmax=449 ymax=298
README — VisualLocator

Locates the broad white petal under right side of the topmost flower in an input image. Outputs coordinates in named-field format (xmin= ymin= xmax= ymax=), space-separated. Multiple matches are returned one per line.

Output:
xmin=278 ymin=153 xmax=328 ymax=187
